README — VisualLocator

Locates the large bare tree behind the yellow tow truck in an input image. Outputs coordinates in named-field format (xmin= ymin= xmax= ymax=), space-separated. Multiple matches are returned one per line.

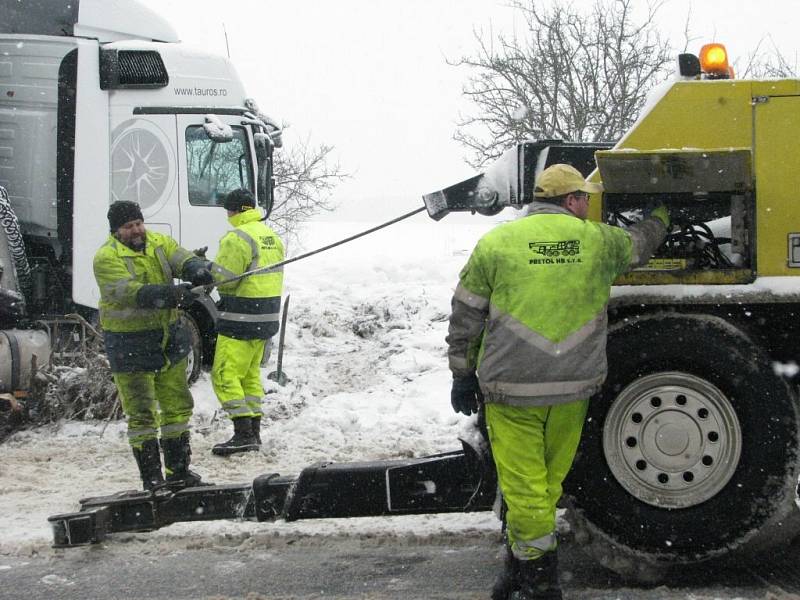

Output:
xmin=450 ymin=0 xmax=674 ymax=168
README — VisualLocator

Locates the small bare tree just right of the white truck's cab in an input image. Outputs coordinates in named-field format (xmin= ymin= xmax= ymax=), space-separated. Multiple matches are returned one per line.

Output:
xmin=270 ymin=138 xmax=349 ymax=244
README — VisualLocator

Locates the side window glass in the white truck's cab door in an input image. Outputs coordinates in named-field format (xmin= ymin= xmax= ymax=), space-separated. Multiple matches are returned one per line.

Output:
xmin=186 ymin=125 xmax=253 ymax=206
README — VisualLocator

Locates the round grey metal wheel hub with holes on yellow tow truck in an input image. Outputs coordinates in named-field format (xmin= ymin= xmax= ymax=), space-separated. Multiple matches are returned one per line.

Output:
xmin=603 ymin=372 xmax=742 ymax=508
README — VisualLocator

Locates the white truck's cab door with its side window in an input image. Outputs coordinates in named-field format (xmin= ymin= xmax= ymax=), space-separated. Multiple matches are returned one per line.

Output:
xmin=177 ymin=114 xmax=255 ymax=258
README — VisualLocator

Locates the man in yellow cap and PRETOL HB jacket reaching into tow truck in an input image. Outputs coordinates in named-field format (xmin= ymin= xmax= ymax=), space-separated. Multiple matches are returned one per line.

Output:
xmin=447 ymin=164 xmax=670 ymax=600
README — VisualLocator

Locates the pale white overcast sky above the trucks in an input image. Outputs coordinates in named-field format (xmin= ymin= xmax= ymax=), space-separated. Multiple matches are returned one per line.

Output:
xmin=136 ymin=0 xmax=800 ymax=219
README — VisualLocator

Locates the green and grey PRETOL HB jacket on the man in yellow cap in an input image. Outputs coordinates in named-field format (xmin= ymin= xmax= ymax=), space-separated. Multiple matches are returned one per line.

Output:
xmin=447 ymin=202 xmax=666 ymax=406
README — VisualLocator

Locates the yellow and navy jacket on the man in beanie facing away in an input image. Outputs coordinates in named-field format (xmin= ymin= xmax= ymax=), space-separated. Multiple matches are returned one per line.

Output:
xmin=213 ymin=210 xmax=284 ymax=340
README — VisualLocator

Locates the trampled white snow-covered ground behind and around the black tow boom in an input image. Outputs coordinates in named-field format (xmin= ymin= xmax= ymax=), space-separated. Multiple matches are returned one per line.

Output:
xmin=0 ymin=213 xmax=499 ymax=556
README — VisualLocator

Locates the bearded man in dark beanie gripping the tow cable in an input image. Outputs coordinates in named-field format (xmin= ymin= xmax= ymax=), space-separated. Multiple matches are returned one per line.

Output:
xmin=94 ymin=201 xmax=213 ymax=490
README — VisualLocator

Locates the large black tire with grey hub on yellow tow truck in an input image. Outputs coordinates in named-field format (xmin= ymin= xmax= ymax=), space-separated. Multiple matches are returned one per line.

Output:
xmin=565 ymin=313 xmax=800 ymax=582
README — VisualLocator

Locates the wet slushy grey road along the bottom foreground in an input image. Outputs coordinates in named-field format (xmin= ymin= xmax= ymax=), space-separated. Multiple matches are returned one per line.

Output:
xmin=0 ymin=524 xmax=800 ymax=600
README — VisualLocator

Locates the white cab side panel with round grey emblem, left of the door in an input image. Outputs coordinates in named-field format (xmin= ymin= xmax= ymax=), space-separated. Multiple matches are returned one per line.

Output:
xmin=110 ymin=113 xmax=181 ymax=239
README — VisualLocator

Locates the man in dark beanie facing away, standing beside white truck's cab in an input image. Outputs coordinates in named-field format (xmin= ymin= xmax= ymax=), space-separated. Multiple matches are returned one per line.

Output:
xmin=211 ymin=189 xmax=284 ymax=456
